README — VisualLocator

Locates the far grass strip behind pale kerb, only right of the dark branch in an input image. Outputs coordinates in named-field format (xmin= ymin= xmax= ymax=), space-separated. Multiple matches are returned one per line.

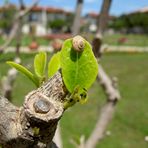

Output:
xmin=103 ymin=34 xmax=148 ymax=47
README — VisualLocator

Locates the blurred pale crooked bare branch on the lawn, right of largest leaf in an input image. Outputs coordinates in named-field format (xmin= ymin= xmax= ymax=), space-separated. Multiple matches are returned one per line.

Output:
xmin=84 ymin=65 xmax=120 ymax=148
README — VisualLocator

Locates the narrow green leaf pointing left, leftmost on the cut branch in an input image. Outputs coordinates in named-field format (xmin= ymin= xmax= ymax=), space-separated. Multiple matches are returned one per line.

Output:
xmin=7 ymin=61 xmax=39 ymax=87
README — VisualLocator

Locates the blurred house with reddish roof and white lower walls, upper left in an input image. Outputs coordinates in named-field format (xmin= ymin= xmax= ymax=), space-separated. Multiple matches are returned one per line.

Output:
xmin=0 ymin=5 xmax=72 ymax=36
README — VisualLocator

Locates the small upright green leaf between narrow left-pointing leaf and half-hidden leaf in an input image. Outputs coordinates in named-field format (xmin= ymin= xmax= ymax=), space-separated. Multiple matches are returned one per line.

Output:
xmin=34 ymin=52 xmax=47 ymax=77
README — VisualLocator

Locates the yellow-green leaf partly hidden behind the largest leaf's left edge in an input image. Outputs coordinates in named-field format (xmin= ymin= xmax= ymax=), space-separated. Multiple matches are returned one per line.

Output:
xmin=48 ymin=52 xmax=61 ymax=78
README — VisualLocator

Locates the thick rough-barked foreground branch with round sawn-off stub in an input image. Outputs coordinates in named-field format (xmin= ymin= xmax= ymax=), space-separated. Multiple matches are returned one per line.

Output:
xmin=0 ymin=72 xmax=68 ymax=148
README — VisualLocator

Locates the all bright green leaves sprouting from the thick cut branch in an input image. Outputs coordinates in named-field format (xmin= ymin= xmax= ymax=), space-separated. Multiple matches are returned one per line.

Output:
xmin=7 ymin=37 xmax=98 ymax=109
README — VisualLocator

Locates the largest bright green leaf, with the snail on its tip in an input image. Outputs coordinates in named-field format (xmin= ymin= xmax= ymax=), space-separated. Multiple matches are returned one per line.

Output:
xmin=60 ymin=39 xmax=98 ymax=92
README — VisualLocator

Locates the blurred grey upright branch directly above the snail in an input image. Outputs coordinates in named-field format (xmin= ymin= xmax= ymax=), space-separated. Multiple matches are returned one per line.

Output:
xmin=72 ymin=0 xmax=83 ymax=36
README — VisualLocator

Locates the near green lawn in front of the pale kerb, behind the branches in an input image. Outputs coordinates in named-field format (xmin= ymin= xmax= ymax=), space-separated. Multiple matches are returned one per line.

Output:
xmin=0 ymin=53 xmax=148 ymax=148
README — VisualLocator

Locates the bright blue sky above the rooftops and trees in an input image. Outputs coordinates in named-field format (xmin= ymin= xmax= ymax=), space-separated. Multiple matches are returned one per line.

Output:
xmin=0 ymin=0 xmax=148 ymax=15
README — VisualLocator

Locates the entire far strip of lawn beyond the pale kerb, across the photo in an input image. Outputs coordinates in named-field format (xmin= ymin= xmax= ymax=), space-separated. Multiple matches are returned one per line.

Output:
xmin=0 ymin=34 xmax=148 ymax=47
